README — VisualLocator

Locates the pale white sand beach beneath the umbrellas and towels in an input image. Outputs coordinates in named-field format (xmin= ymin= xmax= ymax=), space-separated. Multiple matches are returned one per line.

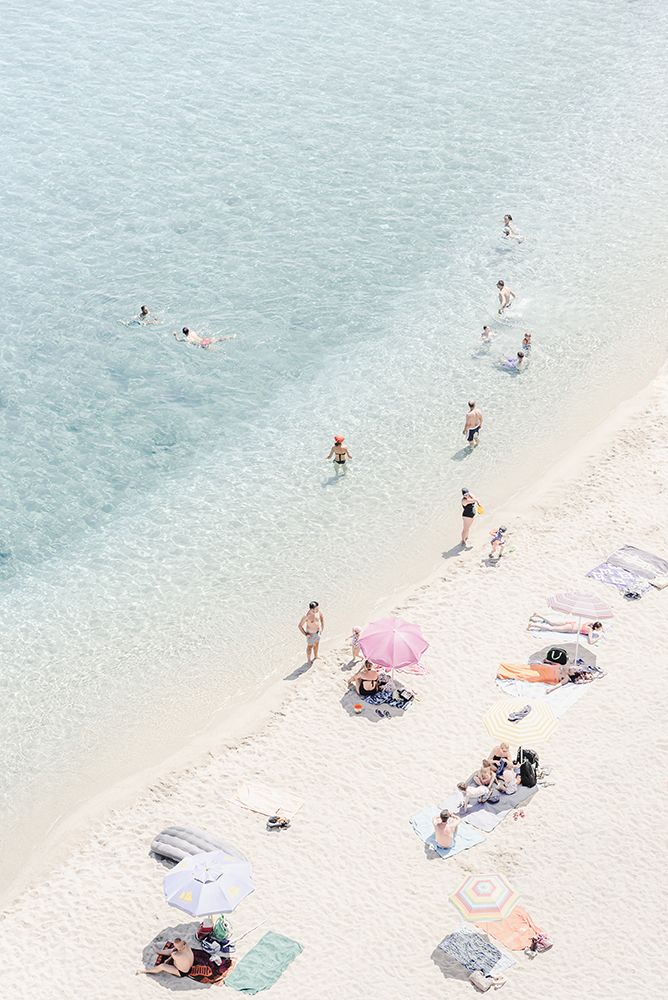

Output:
xmin=0 ymin=372 xmax=668 ymax=1000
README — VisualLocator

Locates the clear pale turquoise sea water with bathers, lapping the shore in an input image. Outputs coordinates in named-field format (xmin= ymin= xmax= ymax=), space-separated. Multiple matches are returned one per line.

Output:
xmin=0 ymin=0 xmax=668 ymax=872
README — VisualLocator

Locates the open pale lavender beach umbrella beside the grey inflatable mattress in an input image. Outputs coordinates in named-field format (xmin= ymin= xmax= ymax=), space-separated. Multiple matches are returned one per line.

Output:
xmin=162 ymin=851 xmax=255 ymax=917
